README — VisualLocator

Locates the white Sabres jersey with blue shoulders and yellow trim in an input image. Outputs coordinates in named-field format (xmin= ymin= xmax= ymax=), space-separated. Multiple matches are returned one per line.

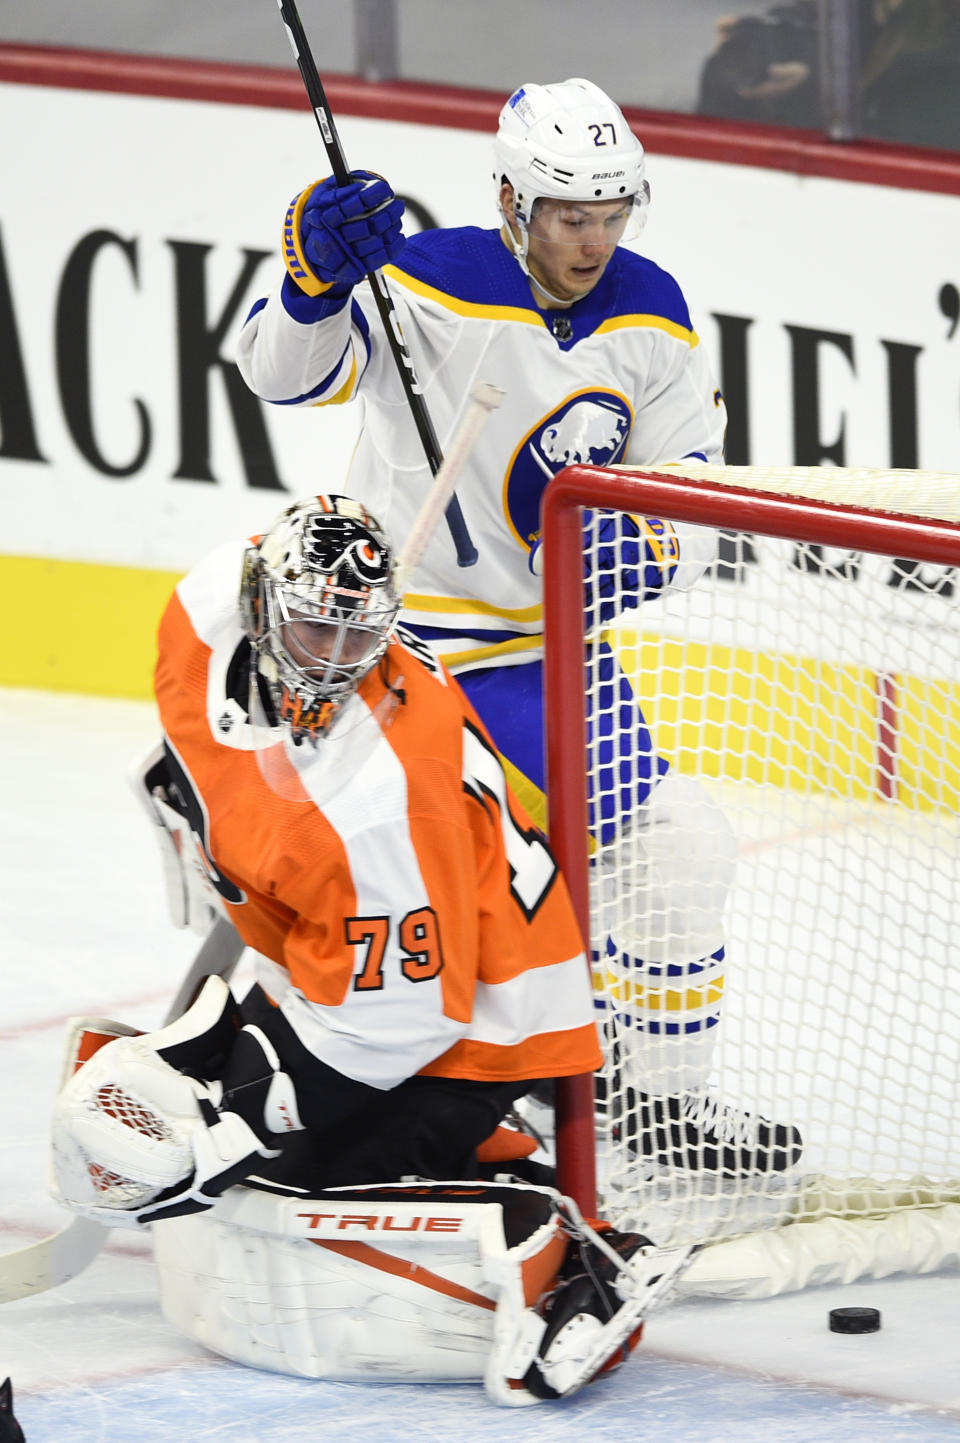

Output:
xmin=238 ymin=227 xmax=726 ymax=671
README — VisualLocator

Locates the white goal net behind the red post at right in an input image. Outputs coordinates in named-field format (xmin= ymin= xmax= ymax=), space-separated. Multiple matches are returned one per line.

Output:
xmin=546 ymin=466 xmax=960 ymax=1294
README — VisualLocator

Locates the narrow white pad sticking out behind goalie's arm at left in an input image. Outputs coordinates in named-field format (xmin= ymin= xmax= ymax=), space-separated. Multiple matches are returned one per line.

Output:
xmin=130 ymin=745 xmax=227 ymax=937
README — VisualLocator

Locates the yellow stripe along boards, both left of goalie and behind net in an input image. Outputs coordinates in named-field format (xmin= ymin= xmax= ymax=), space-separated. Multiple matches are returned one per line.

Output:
xmin=9 ymin=556 xmax=960 ymax=821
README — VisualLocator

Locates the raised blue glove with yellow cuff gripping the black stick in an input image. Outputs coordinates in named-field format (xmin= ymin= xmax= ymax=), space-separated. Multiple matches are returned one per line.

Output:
xmin=283 ymin=170 xmax=406 ymax=296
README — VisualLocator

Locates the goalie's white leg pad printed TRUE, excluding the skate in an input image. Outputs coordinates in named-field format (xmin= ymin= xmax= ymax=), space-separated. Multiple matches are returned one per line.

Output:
xmin=153 ymin=1182 xmax=566 ymax=1382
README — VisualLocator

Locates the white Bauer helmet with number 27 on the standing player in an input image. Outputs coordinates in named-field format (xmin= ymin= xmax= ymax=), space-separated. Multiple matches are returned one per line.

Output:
xmin=494 ymin=79 xmax=650 ymax=227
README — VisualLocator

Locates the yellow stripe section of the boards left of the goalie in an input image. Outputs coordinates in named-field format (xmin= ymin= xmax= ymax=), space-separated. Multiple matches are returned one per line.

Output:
xmin=0 ymin=556 xmax=182 ymax=698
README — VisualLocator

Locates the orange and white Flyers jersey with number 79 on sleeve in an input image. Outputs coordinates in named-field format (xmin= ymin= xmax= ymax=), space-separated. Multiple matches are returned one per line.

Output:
xmin=156 ymin=543 xmax=601 ymax=1088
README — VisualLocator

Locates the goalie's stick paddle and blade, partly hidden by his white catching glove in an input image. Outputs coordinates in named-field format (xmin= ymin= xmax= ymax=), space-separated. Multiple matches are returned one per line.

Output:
xmin=0 ymin=918 xmax=244 ymax=1303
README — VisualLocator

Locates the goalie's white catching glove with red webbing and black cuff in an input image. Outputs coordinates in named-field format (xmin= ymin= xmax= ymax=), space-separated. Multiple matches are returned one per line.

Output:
xmin=51 ymin=977 xmax=302 ymax=1227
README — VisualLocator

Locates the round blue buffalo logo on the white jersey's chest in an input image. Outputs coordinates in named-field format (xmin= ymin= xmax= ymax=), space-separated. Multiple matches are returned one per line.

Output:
xmin=504 ymin=390 xmax=634 ymax=547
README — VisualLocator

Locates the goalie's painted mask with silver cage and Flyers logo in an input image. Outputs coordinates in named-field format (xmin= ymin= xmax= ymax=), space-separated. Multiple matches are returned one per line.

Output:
xmin=240 ymin=496 xmax=400 ymax=743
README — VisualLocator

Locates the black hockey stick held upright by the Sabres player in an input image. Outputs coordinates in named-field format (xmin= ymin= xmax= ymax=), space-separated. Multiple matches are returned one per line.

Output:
xmin=277 ymin=0 xmax=478 ymax=566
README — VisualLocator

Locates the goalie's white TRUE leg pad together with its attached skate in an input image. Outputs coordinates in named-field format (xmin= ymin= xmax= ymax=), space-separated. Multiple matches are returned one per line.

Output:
xmin=153 ymin=1177 xmax=694 ymax=1407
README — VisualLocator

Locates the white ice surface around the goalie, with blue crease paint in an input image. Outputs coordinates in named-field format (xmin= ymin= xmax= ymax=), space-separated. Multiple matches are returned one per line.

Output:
xmin=0 ymin=690 xmax=960 ymax=1443
